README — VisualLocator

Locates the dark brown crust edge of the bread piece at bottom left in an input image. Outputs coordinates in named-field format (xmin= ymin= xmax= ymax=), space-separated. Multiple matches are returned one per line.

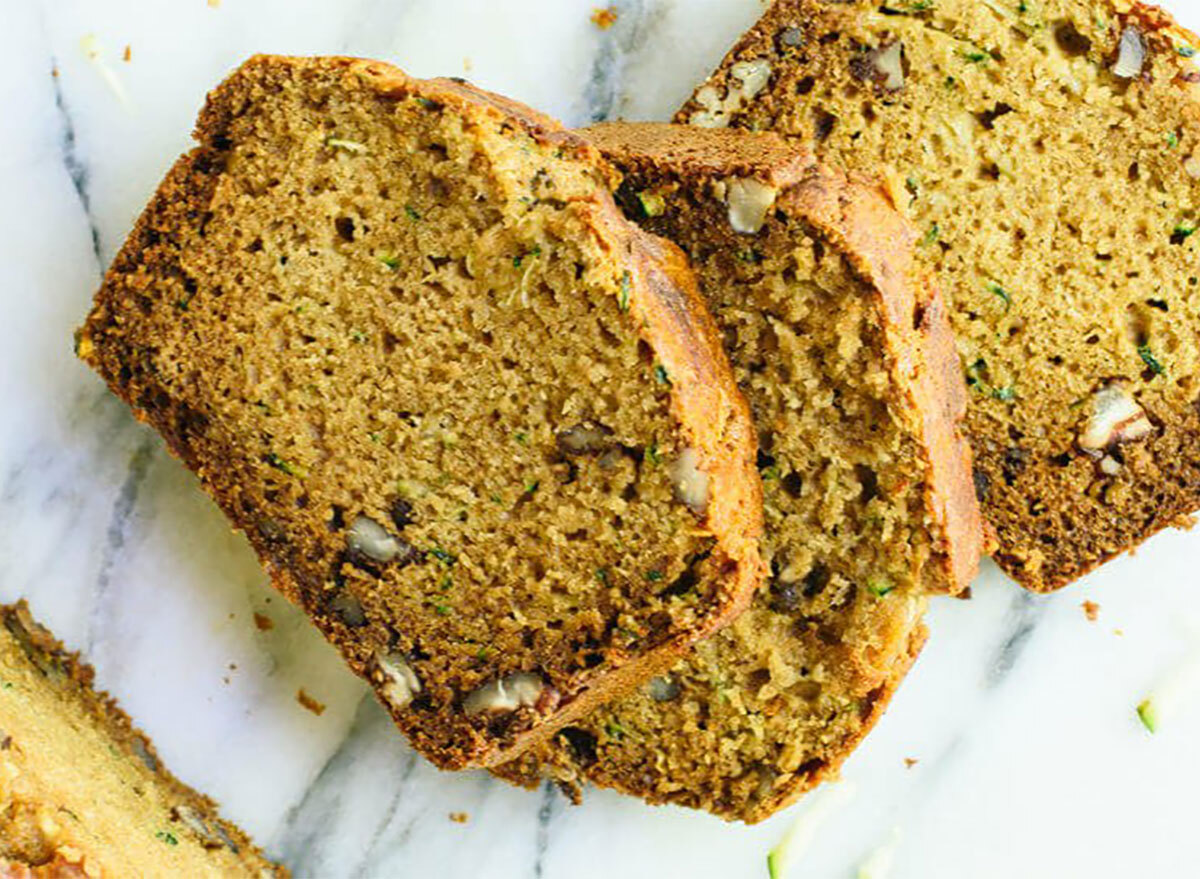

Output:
xmin=0 ymin=599 xmax=290 ymax=879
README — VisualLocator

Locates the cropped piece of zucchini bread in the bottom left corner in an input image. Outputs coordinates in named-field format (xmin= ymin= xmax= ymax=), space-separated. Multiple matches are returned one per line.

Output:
xmin=0 ymin=602 xmax=288 ymax=879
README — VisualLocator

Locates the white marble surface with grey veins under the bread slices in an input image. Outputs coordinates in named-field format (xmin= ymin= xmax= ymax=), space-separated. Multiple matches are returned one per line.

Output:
xmin=0 ymin=0 xmax=1200 ymax=879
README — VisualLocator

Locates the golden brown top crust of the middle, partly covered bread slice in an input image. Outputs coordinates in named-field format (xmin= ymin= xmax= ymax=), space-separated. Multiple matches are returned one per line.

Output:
xmin=582 ymin=122 xmax=984 ymax=592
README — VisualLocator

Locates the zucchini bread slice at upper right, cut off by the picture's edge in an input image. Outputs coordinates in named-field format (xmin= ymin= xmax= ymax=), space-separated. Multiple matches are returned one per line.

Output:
xmin=678 ymin=0 xmax=1200 ymax=591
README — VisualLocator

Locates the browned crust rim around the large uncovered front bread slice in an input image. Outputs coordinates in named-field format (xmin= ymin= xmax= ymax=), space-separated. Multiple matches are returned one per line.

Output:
xmin=79 ymin=56 xmax=762 ymax=769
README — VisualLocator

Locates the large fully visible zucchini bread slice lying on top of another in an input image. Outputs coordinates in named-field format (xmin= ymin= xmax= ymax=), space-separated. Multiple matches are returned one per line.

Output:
xmin=79 ymin=58 xmax=761 ymax=769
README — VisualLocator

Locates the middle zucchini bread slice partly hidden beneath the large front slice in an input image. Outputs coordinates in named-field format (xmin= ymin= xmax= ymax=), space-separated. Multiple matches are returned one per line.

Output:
xmin=489 ymin=124 xmax=983 ymax=821
